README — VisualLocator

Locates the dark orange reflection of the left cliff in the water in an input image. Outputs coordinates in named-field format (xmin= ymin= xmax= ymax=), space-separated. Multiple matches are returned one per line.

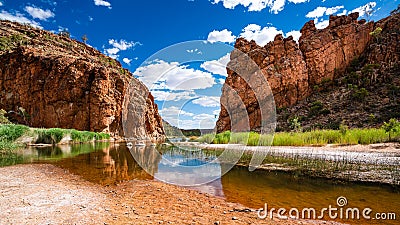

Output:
xmin=55 ymin=143 xmax=161 ymax=185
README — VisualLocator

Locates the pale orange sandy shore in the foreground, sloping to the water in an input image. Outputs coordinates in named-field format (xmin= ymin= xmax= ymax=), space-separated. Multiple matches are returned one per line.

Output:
xmin=0 ymin=164 xmax=344 ymax=224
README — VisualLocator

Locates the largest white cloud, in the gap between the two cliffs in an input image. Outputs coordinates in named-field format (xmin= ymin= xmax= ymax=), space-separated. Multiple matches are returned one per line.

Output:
xmin=133 ymin=60 xmax=215 ymax=90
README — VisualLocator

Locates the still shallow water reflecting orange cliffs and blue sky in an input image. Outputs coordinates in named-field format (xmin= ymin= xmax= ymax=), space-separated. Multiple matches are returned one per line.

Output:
xmin=1 ymin=143 xmax=400 ymax=224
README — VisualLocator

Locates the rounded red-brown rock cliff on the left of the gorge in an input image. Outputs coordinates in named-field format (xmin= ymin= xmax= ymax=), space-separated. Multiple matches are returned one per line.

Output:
xmin=0 ymin=21 xmax=164 ymax=138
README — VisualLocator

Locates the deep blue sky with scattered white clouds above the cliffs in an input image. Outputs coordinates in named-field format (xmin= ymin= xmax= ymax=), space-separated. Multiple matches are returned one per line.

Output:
xmin=0 ymin=0 xmax=400 ymax=128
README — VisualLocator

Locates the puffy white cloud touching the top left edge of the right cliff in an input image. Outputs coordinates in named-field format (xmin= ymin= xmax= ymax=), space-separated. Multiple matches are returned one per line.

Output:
xmin=240 ymin=24 xmax=283 ymax=46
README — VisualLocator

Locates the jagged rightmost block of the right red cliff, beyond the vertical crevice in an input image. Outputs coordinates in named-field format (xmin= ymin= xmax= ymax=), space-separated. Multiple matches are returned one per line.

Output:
xmin=299 ymin=13 xmax=374 ymax=85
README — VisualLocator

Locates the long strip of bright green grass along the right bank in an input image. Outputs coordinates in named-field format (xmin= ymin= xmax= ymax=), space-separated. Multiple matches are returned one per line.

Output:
xmin=197 ymin=128 xmax=400 ymax=146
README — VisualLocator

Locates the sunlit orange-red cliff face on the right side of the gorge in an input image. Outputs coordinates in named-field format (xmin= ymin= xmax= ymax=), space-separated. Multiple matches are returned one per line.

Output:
xmin=217 ymin=13 xmax=374 ymax=132
